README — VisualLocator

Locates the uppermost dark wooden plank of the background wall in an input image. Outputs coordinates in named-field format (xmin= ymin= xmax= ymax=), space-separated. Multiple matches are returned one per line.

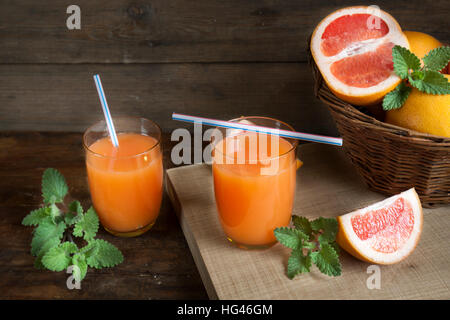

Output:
xmin=0 ymin=0 xmax=450 ymax=63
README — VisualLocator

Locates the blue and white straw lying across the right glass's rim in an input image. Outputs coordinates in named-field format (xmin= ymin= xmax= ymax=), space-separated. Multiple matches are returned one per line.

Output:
xmin=172 ymin=113 xmax=342 ymax=146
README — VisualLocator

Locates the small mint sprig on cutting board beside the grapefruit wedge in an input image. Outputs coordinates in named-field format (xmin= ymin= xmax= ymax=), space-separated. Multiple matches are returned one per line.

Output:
xmin=274 ymin=216 xmax=342 ymax=279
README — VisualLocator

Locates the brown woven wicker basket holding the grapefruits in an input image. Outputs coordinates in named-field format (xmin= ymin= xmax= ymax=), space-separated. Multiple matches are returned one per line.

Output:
xmin=308 ymin=44 xmax=450 ymax=207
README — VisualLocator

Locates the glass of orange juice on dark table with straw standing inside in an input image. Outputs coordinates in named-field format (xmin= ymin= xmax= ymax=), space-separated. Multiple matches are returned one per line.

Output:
xmin=83 ymin=117 xmax=163 ymax=237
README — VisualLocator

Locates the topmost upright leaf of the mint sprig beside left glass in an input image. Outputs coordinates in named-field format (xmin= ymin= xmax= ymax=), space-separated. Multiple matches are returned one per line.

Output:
xmin=42 ymin=168 xmax=68 ymax=204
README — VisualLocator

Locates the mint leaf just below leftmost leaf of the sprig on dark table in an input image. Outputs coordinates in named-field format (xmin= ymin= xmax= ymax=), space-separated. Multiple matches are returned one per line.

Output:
xmin=31 ymin=217 xmax=66 ymax=256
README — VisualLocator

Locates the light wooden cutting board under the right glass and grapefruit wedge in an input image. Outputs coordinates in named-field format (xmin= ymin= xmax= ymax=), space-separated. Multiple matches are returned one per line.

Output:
xmin=166 ymin=144 xmax=450 ymax=299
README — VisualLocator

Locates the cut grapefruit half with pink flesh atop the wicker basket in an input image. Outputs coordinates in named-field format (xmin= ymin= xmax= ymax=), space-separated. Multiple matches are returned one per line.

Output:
xmin=311 ymin=6 xmax=409 ymax=106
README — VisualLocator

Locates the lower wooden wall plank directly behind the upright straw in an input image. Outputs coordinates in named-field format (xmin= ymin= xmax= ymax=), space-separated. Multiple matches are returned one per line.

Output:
xmin=0 ymin=63 xmax=337 ymax=135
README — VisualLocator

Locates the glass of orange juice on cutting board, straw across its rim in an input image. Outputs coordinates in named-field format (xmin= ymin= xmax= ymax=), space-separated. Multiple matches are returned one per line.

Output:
xmin=212 ymin=117 xmax=298 ymax=249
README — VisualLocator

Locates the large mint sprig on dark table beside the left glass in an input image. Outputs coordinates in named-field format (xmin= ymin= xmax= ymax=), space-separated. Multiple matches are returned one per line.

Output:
xmin=22 ymin=168 xmax=123 ymax=281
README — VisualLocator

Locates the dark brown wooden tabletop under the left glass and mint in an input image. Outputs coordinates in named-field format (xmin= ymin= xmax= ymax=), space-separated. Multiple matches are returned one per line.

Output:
xmin=0 ymin=132 xmax=207 ymax=299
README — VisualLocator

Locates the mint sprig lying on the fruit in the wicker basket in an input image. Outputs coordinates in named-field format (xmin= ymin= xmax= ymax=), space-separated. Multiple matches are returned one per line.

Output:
xmin=383 ymin=46 xmax=450 ymax=111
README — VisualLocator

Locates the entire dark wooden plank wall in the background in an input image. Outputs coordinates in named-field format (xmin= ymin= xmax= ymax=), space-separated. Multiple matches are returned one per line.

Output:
xmin=0 ymin=0 xmax=450 ymax=135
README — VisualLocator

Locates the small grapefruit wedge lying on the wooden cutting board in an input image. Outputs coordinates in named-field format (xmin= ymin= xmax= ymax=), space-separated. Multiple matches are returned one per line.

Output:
xmin=336 ymin=188 xmax=423 ymax=264
